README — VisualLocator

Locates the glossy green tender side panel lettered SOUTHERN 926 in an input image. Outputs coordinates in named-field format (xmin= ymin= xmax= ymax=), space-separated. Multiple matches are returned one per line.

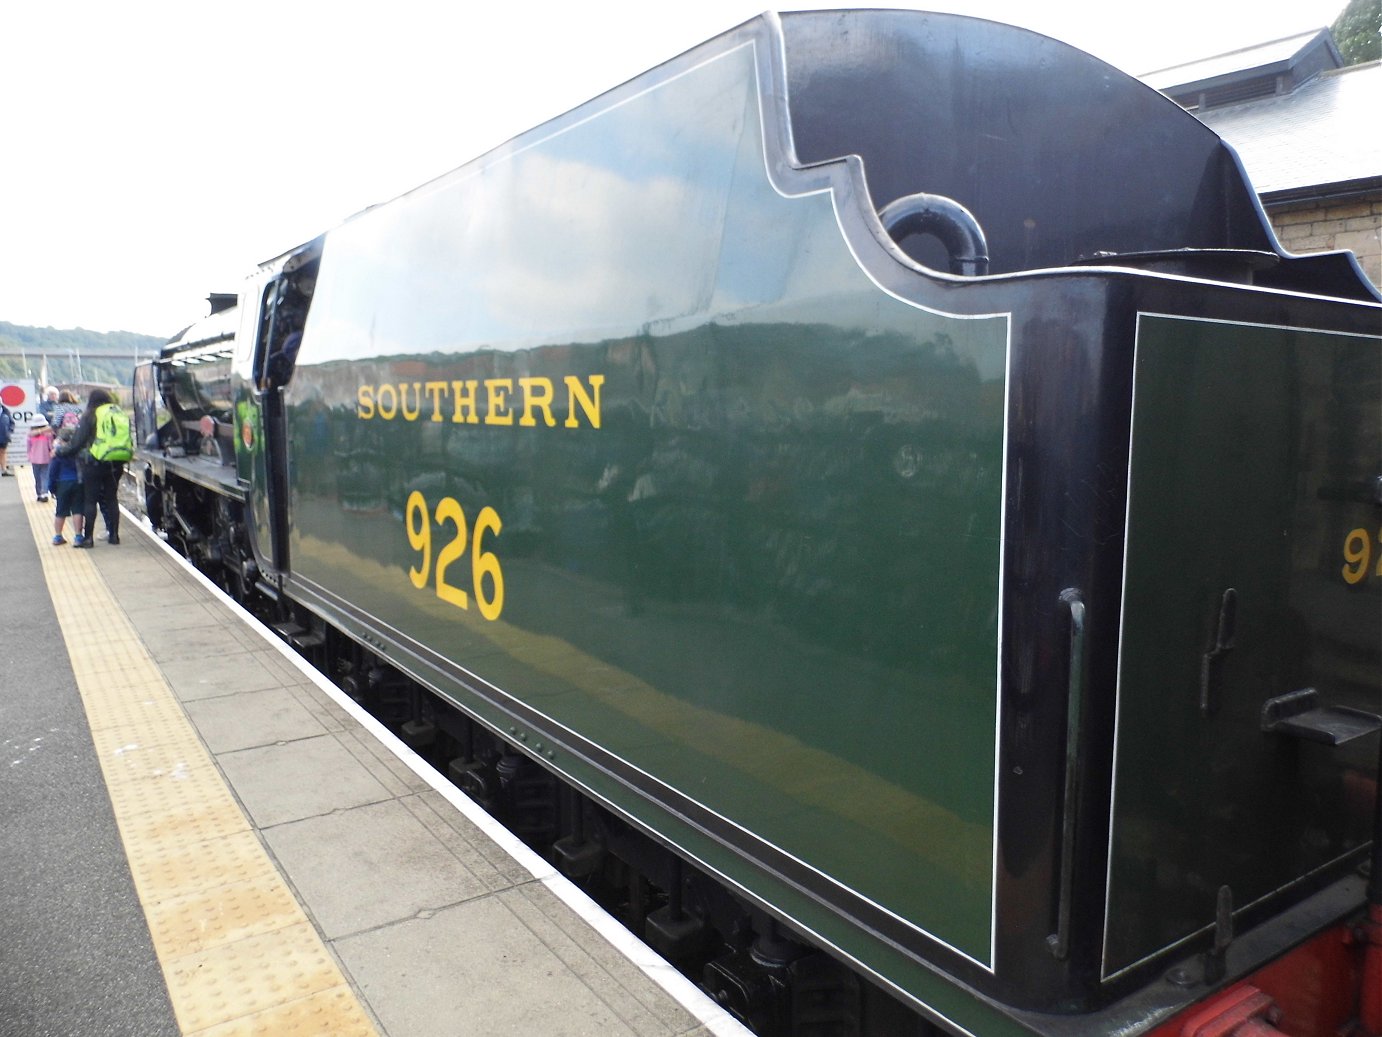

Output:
xmin=287 ymin=46 xmax=1006 ymax=968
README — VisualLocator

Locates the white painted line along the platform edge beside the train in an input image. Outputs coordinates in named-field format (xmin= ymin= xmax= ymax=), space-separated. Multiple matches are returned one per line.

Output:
xmin=120 ymin=506 xmax=752 ymax=1037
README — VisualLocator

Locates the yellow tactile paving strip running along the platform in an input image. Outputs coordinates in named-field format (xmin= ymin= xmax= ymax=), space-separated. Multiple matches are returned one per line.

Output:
xmin=18 ymin=469 xmax=376 ymax=1037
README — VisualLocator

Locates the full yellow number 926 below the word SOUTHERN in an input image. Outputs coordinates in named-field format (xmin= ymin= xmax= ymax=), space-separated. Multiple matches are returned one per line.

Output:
xmin=404 ymin=489 xmax=504 ymax=619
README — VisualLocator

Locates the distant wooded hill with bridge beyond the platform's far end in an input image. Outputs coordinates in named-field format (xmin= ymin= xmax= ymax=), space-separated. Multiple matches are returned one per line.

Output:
xmin=0 ymin=321 xmax=167 ymax=386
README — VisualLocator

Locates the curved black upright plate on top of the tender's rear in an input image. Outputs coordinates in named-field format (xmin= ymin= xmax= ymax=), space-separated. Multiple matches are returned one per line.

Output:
xmin=782 ymin=11 xmax=1376 ymax=296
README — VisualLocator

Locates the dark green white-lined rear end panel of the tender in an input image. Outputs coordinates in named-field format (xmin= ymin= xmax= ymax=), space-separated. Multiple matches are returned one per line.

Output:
xmin=1106 ymin=315 xmax=1382 ymax=973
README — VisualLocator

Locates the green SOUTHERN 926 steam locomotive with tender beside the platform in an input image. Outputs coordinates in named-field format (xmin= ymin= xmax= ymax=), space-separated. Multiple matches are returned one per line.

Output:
xmin=135 ymin=11 xmax=1382 ymax=1037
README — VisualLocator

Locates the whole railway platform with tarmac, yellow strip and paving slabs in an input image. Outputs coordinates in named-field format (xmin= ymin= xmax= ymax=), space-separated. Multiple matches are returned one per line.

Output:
xmin=0 ymin=466 xmax=746 ymax=1037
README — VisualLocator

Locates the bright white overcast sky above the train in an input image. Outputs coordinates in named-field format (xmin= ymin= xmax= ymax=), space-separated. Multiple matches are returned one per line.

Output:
xmin=0 ymin=0 xmax=1346 ymax=335
